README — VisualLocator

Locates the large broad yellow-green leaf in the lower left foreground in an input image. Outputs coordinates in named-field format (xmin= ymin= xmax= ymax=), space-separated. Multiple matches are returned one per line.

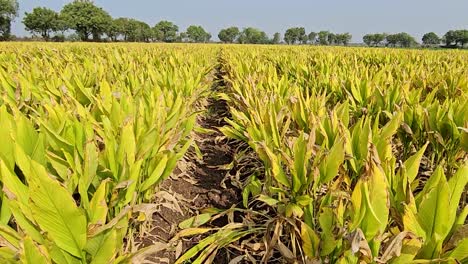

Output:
xmin=30 ymin=161 xmax=86 ymax=258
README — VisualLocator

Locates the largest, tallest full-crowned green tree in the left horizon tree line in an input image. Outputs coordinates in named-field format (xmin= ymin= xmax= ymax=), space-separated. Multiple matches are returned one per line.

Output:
xmin=61 ymin=0 xmax=112 ymax=41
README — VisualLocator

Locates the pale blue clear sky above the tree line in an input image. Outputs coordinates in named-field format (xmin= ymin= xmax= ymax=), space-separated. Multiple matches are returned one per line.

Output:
xmin=13 ymin=0 xmax=468 ymax=42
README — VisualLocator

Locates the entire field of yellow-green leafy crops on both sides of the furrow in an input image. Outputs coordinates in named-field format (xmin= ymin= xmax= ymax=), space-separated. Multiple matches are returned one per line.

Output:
xmin=0 ymin=43 xmax=468 ymax=264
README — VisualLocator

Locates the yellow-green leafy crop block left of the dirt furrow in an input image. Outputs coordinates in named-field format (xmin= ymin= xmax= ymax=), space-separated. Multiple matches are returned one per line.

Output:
xmin=0 ymin=44 xmax=215 ymax=263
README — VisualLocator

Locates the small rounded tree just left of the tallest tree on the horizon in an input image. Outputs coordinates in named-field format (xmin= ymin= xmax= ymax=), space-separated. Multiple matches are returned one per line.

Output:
xmin=23 ymin=7 xmax=61 ymax=40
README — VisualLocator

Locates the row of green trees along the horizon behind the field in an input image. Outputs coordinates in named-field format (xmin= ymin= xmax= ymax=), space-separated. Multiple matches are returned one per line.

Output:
xmin=0 ymin=0 xmax=468 ymax=48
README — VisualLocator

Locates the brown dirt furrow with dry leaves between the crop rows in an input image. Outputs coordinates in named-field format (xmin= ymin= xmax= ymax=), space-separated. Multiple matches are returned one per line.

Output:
xmin=141 ymin=69 xmax=241 ymax=264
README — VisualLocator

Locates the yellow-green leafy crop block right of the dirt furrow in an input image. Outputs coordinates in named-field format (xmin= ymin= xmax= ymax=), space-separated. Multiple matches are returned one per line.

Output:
xmin=182 ymin=47 xmax=468 ymax=263
